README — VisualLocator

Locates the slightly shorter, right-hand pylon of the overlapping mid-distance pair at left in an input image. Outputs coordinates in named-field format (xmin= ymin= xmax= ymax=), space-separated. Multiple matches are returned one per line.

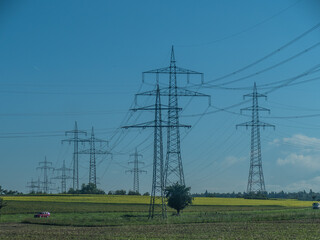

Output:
xmin=79 ymin=127 xmax=111 ymax=187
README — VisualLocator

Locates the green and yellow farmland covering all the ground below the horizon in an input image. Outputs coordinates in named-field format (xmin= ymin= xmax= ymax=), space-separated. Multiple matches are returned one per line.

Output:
xmin=0 ymin=195 xmax=320 ymax=239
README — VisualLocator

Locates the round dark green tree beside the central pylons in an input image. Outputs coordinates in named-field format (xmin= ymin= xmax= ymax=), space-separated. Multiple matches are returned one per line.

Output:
xmin=165 ymin=183 xmax=192 ymax=216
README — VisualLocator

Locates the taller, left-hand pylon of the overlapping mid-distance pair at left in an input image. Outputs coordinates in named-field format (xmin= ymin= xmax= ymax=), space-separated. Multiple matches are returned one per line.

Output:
xmin=62 ymin=121 xmax=87 ymax=190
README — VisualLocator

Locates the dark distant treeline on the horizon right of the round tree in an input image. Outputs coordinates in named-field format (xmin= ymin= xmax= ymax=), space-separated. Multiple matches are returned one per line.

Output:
xmin=192 ymin=189 xmax=320 ymax=201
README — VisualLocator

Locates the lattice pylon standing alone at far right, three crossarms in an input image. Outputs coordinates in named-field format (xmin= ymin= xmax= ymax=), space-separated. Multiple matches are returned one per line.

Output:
xmin=236 ymin=83 xmax=275 ymax=193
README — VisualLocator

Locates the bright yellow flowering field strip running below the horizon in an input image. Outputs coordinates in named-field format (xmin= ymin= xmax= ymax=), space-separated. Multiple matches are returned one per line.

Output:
xmin=3 ymin=194 xmax=312 ymax=207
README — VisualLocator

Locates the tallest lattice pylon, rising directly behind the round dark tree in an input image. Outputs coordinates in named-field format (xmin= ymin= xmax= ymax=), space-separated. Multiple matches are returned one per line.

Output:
xmin=142 ymin=46 xmax=210 ymax=187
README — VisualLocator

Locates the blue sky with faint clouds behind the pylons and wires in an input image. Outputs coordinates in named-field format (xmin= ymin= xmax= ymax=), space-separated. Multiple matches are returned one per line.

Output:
xmin=0 ymin=0 xmax=320 ymax=192
